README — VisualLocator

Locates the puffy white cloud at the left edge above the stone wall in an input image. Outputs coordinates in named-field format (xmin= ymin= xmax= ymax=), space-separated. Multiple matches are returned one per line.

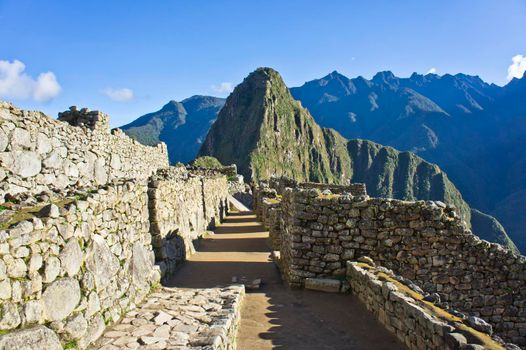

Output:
xmin=0 ymin=60 xmax=62 ymax=102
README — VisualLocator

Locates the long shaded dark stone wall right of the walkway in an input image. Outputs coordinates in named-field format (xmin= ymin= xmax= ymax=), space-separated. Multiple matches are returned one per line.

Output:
xmin=255 ymin=182 xmax=526 ymax=346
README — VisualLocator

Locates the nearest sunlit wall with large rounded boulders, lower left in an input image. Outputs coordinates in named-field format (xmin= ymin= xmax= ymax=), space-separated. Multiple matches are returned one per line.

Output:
xmin=0 ymin=182 xmax=160 ymax=348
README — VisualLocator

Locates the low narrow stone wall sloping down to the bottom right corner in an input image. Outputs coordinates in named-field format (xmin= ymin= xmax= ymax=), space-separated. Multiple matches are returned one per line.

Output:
xmin=347 ymin=262 xmax=513 ymax=350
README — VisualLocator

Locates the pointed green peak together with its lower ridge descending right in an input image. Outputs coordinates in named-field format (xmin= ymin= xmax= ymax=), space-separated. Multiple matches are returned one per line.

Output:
xmin=199 ymin=68 xmax=482 ymax=232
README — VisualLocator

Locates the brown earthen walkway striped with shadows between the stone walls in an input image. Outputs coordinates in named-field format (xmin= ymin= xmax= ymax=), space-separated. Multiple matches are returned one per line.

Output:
xmin=168 ymin=212 xmax=404 ymax=350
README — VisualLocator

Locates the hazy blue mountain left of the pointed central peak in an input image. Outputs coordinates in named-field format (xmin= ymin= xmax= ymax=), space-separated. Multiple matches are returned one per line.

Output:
xmin=121 ymin=96 xmax=225 ymax=164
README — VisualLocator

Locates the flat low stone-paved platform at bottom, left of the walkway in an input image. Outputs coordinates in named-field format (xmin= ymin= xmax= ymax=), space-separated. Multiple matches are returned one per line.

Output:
xmin=93 ymin=285 xmax=245 ymax=350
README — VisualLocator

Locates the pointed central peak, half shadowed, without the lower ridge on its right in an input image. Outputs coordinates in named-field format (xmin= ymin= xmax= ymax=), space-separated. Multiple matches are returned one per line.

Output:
xmin=199 ymin=68 xmax=350 ymax=183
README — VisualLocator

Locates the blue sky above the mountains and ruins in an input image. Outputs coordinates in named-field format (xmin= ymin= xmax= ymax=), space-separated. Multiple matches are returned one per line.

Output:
xmin=0 ymin=0 xmax=526 ymax=126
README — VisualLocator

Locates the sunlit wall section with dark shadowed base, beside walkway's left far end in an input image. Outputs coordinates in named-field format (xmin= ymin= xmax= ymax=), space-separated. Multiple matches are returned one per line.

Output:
xmin=148 ymin=167 xmax=228 ymax=276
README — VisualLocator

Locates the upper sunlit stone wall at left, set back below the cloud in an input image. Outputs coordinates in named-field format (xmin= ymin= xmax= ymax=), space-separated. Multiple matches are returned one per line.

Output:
xmin=0 ymin=102 xmax=168 ymax=203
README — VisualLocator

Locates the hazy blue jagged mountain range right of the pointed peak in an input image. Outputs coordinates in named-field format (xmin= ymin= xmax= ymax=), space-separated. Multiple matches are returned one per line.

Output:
xmin=291 ymin=72 xmax=526 ymax=251
